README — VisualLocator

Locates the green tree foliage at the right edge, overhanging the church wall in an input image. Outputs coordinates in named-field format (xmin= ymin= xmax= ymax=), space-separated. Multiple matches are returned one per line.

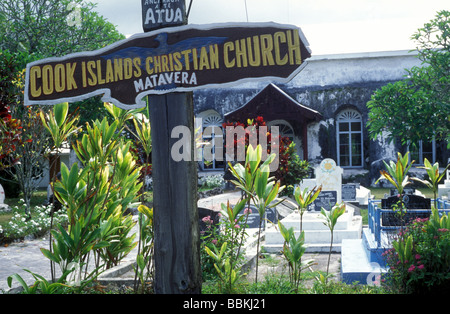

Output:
xmin=367 ymin=11 xmax=450 ymax=144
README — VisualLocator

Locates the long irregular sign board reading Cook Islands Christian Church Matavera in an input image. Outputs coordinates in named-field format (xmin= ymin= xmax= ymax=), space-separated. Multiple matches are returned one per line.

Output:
xmin=25 ymin=23 xmax=311 ymax=109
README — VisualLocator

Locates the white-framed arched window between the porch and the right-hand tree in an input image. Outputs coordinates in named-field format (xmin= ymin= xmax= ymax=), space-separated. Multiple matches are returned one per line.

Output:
xmin=336 ymin=109 xmax=364 ymax=167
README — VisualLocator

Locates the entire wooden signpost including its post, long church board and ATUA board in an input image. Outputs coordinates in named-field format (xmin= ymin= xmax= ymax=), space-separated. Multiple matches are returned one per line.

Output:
xmin=24 ymin=0 xmax=311 ymax=293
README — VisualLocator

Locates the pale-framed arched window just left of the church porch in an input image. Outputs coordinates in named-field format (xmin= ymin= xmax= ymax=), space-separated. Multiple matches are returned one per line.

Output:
xmin=201 ymin=112 xmax=225 ymax=170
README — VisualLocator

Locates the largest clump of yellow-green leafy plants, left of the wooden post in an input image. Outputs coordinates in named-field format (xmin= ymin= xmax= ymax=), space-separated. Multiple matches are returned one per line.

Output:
xmin=42 ymin=106 xmax=142 ymax=284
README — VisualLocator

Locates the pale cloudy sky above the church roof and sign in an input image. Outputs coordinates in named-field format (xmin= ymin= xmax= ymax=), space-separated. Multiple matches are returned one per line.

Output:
xmin=90 ymin=0 xmax=450 ymax=55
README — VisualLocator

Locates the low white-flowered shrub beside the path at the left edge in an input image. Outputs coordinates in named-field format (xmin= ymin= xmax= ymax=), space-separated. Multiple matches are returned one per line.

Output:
xmin=0 ymin=199 xmax=67 ymax=243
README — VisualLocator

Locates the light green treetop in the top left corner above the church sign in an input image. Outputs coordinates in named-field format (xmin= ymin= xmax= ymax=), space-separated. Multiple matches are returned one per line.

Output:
xmin=0 ymin=0 xmax=125 ymax=57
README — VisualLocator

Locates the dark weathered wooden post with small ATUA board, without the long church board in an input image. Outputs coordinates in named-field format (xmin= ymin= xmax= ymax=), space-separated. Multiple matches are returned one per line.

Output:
xmin=142 ymin=0 xmax=202 ymax=294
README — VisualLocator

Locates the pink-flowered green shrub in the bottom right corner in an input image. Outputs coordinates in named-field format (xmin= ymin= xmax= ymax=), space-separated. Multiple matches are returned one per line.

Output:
xmin=385 ymin=211 xmax=450 ymax=294
